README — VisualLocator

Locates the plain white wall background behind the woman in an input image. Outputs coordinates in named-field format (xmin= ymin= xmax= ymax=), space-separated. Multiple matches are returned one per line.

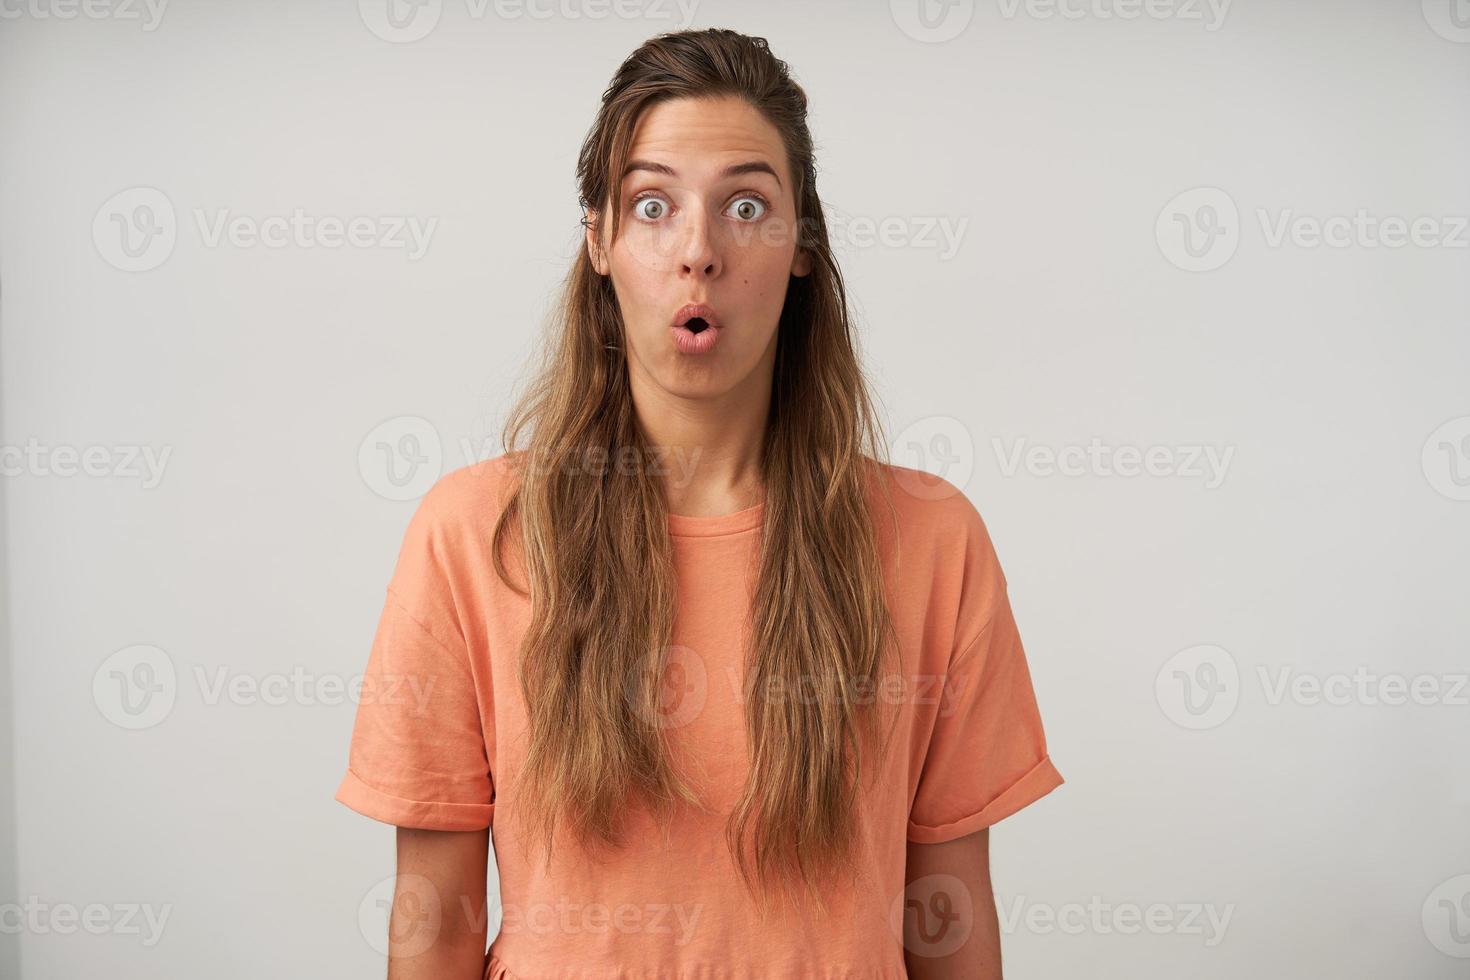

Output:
xmin=0 ymin=0 xmax=1470 ymax=980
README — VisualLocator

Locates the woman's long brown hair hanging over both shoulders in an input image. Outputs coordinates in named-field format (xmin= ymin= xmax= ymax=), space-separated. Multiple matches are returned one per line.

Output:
xmin=494 ymin=29 xmax=897 ymax=908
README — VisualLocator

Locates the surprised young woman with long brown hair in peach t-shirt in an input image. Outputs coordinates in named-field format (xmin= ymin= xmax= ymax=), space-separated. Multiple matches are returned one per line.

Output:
xmin=337 ymin=29 xmax=1061 ymax=980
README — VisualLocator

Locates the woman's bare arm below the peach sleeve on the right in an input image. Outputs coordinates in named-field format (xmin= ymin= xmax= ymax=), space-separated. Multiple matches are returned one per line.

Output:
xmin=904 ymin=827 xmax=1001 ymax=980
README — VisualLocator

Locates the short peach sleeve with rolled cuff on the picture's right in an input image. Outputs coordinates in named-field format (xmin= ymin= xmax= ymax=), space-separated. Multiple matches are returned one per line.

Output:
xmin=908 ymin=589 xmax=1063 ymax=843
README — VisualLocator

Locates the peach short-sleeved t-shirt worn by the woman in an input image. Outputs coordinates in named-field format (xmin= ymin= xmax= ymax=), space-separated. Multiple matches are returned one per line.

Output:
xmin=337 ymin=455 xmax=1063 ymax=980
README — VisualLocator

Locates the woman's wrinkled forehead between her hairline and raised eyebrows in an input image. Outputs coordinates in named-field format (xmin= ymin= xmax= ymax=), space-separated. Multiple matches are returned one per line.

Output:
xmin=628 ymin=97 xmax=788 ymax=187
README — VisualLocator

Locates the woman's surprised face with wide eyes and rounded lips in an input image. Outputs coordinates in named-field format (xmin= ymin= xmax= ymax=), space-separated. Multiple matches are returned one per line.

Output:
xmin=587 ymin=97 xmax=810 ymax=398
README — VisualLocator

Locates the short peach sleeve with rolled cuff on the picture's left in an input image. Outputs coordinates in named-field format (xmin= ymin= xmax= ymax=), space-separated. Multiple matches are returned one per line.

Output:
xmin=335 ymin=491 xmax=495 ymax=830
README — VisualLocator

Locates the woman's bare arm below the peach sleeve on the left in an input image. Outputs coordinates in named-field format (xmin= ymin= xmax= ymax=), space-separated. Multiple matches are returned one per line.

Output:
xmin=388 ymin=827 xmax=490 ymax=980
